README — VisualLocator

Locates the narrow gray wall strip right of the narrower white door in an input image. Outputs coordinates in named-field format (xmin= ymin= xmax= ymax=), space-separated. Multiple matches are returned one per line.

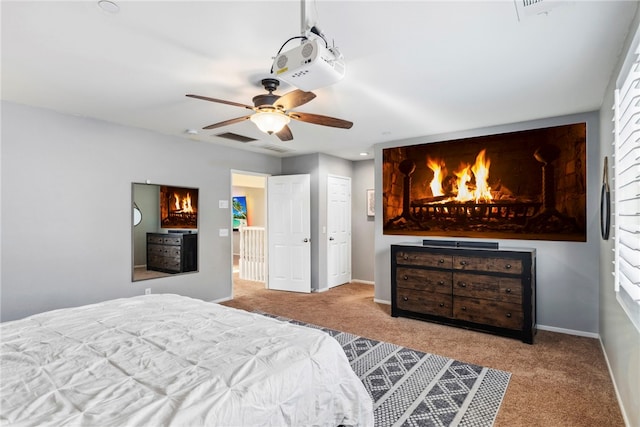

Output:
xmin=351 ymin=160 xmax=375 ymax=283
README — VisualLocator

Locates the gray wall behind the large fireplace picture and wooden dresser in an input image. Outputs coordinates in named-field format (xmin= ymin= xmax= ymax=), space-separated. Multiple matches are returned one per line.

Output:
xmin=375 ymin=113 xmax=601 ymax=337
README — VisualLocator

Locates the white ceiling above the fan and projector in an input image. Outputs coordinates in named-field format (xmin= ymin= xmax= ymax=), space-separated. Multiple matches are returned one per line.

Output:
xmin=1 ymin=0 xmax=638 ymax=160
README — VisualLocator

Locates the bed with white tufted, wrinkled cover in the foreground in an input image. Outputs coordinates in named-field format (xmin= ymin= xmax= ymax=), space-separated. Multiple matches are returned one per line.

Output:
xmin=0 ymin=294 xmax=373 ymax=427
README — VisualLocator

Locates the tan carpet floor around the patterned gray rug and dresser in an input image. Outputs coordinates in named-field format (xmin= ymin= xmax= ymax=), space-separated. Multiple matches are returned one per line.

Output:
xmin=225 ymin=280 xmax=624 ymax=427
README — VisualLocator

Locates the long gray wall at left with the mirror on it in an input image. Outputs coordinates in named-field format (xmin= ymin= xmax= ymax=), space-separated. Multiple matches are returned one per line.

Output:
xmin=1 ymin=102 xmax=281 ymax=321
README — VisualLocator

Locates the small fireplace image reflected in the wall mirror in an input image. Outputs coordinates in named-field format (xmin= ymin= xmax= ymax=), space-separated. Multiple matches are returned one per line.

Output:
xmin=160 ymin=185 xmax=198 ymax=229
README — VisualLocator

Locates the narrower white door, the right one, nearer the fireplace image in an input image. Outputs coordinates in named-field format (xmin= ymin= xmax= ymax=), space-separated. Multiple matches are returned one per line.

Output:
xmin=326 ymin=176 xmax=351 ymax=288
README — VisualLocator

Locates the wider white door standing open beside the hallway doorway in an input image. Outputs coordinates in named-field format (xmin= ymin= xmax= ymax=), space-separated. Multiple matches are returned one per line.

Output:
xmin=267 ymin=175 xmax=311 ymax=292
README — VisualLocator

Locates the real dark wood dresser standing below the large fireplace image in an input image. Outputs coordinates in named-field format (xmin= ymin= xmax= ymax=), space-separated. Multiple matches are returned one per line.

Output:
xmin=391 ymin=244 xmax=536 ymax=344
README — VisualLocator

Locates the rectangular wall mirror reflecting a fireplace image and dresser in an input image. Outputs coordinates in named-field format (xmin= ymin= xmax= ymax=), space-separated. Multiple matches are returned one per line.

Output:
xmin=131 ymin=183 xmax=198 ymax=282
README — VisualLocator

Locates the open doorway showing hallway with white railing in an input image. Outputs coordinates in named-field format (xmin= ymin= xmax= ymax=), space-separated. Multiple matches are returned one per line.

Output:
xmin=230 ymin=170 xmax=268 ymax=297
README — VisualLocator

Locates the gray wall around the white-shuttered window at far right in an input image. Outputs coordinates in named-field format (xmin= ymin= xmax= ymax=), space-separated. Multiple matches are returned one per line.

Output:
xmin=598 ymin=8 xmax=640 ymax=426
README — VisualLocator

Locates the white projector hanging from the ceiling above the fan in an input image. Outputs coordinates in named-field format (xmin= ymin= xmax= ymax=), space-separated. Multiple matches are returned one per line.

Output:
xmin=272 ymin=39 xmax=345 ymax=92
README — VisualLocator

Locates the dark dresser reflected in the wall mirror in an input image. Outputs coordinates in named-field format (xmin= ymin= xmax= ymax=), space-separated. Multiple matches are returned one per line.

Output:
xmin=147 ymin=233 xmax=198 ymax=273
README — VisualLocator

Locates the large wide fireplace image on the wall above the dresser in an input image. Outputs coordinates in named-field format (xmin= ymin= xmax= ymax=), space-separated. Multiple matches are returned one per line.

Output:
xmin=383 ymin=123 xmax=586 ymax=241
